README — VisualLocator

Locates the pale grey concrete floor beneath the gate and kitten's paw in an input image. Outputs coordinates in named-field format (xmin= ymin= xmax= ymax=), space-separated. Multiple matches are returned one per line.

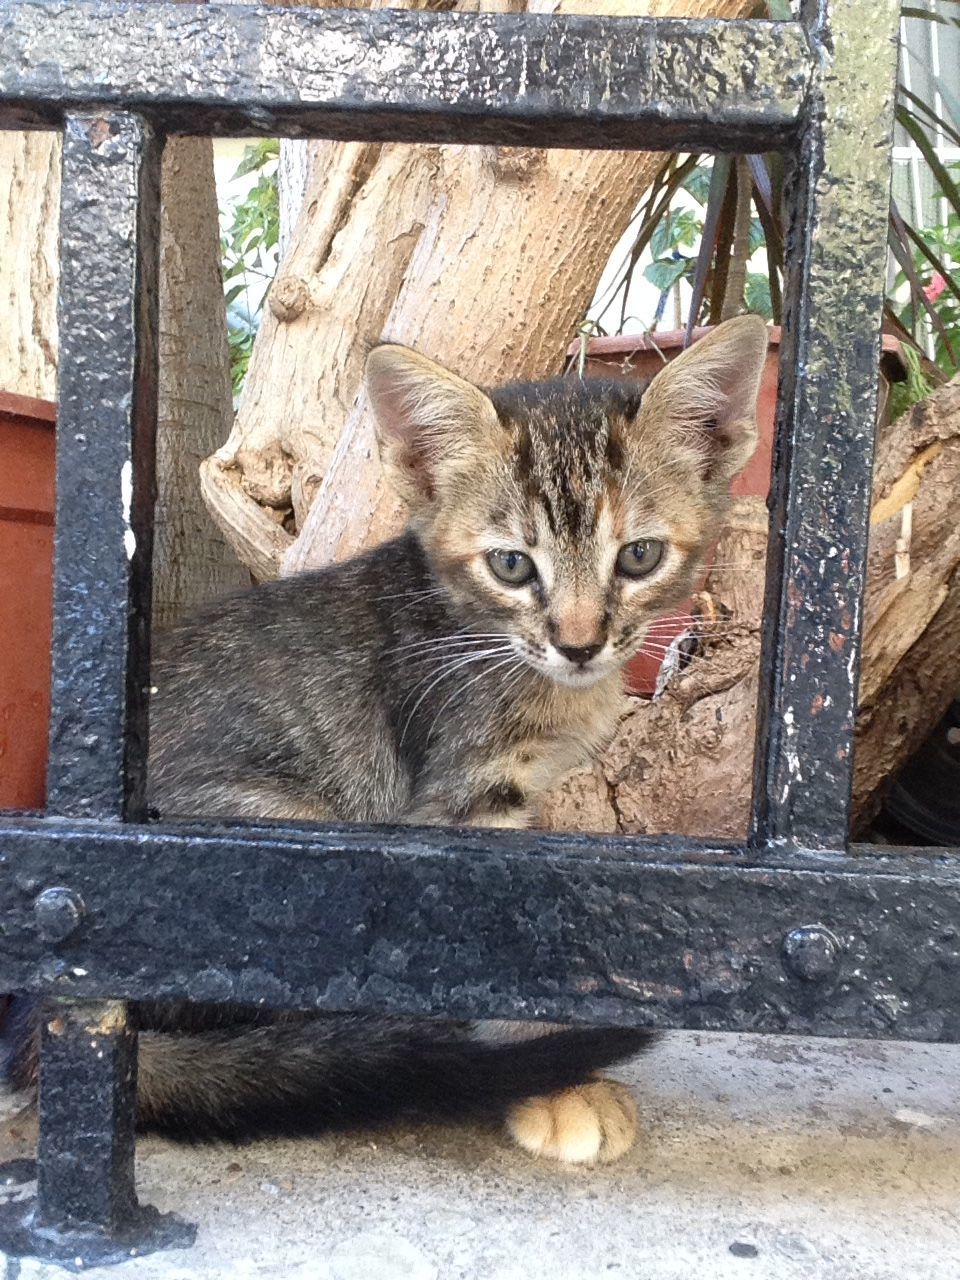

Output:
xmin=0 ymin=1033 xmax=960 ymax=1280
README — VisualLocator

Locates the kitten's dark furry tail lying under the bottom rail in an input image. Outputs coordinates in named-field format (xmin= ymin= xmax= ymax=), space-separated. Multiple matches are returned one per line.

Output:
xmin=0 ymin=998 xmax=655 ymax=1142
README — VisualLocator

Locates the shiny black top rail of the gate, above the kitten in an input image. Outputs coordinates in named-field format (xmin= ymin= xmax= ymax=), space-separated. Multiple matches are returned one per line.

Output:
xmin=0 ymin=0 xmax=810 ymax=151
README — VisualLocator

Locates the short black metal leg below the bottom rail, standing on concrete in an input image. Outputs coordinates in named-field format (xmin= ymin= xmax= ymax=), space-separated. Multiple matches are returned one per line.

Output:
xmin=35 ymin=1000 xmax=137 ymax=1236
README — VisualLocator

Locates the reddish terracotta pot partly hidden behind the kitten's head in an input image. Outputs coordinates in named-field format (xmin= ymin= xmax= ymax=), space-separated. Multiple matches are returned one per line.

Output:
xmin=567 ymin=325 xmax=905 ymax=696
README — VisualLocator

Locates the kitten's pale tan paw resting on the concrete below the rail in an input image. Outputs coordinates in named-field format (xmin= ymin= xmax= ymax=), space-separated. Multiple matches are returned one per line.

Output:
xmin=507 ymin=1079 xmax=636 ymax=1165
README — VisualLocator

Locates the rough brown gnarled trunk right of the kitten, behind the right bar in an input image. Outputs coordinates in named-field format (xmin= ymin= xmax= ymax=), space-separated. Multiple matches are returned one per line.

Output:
xmin=541 ymin=376 xmax=960 ymax=838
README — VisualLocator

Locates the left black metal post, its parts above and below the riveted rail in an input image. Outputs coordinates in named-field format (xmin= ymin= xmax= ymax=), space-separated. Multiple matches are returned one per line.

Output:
xmin=35 ymin=114 xmax=161 ymax=1239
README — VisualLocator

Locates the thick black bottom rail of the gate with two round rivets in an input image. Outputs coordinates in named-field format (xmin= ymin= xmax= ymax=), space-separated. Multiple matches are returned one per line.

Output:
xmin=0 ymin=817 xmax=960 ymax=1041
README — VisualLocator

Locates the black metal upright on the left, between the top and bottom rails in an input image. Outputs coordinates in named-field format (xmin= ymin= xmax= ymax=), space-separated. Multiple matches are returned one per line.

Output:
xmin=47 ymin=114 xmax=160 ymax=818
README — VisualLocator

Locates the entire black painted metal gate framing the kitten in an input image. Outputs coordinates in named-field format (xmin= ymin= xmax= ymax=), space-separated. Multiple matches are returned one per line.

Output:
xmin=0 ymin=0 xmax=960 ymax=1262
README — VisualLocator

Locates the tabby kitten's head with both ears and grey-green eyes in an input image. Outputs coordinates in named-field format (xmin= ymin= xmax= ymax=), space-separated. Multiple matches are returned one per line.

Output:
xmin=367 ymin=316 xmax=767 ymax=686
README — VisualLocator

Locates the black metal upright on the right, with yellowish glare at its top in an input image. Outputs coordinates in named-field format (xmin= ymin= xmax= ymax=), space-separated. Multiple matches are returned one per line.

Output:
xmin=754 ymin=0 xmax=899 ymax=847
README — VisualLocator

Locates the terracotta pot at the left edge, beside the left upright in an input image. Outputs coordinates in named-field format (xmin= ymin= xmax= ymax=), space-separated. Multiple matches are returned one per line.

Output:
xmin=0 ymin=392 xmax=56 ymax=809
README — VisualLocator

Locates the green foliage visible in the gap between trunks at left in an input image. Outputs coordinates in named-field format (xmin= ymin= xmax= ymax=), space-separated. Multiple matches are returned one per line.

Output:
xmin=220 ymin=138 xmax=280 ymax=396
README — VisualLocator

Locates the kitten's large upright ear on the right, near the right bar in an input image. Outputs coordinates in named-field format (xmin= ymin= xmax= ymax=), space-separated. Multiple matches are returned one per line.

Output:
xmin=640 ymin=316 xmax=769 ymax=483
